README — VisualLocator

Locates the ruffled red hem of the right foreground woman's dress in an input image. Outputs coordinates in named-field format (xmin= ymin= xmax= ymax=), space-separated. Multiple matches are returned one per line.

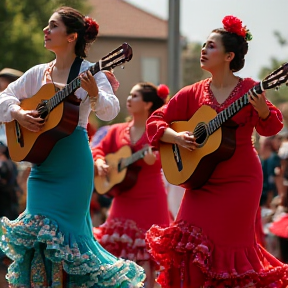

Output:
xmin=146 ymin=221 xmax=288 ymax=288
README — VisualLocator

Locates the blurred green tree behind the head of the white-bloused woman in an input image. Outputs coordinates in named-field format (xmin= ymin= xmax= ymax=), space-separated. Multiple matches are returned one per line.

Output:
xmin=0 ymin=0 xmax=89 ymax=71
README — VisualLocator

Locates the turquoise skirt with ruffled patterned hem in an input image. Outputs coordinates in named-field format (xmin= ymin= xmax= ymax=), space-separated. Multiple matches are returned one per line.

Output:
xmin=0 ymin=127 xmax=145 ymax=288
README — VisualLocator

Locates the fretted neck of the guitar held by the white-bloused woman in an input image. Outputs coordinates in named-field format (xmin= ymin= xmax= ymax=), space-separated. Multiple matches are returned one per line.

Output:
xmin=47 ymin=61 xmax=101 ymax=111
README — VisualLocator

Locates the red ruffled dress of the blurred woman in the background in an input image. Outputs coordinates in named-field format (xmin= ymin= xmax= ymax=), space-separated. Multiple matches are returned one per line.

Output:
xmin=92 ymin=122 xmax=170 ymax=262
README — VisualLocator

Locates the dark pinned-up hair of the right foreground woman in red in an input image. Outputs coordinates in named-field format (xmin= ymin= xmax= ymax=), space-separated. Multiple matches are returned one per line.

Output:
xmin=212 ymin=28 xmax=248 ymax=72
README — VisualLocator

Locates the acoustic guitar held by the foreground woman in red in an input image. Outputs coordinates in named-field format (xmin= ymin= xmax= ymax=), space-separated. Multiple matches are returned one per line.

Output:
xmin=159 ymin=63 xmax=288 ymax=189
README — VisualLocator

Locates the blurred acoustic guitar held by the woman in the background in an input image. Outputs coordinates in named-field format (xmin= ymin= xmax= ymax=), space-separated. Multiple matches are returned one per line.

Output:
xmin=94 ymin=145 xmax=149 ymax=196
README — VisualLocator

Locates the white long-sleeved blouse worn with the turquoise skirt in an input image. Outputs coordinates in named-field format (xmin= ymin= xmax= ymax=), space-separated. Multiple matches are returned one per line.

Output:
xmin=0 ymin=60 xmax=120 ymax=128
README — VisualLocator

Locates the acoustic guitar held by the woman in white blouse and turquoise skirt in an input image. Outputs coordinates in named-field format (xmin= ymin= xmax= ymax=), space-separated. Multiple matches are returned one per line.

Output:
xmin=5 ymin=43 xmax=133 ymax=164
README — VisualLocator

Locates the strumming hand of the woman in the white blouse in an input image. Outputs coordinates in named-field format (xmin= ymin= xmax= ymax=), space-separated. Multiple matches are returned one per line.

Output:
xmin=11 ymin=108 xmax=45 ymax=132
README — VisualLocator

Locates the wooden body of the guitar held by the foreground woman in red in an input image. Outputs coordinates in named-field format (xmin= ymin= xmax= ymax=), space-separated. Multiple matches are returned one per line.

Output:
xmin=160 ymin=105 xmax=237 ymax=189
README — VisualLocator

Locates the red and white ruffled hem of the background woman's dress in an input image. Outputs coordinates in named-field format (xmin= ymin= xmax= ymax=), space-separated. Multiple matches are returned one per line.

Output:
xmin=93 ymin=218 xmax=152 ymax=262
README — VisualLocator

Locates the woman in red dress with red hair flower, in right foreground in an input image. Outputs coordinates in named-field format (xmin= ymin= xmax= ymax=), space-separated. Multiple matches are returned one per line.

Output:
xmin=146 ymin=16 xmax=287 ymax=288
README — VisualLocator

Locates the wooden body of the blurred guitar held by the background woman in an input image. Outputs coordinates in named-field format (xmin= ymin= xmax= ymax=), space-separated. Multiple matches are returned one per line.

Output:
xmin=94 ymin=146 xmax=141 ymax=196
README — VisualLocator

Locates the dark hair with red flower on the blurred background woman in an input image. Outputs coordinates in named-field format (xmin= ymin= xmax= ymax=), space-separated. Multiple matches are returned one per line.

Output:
xmin=136 ymin=82 xmax=169 ymax=113
